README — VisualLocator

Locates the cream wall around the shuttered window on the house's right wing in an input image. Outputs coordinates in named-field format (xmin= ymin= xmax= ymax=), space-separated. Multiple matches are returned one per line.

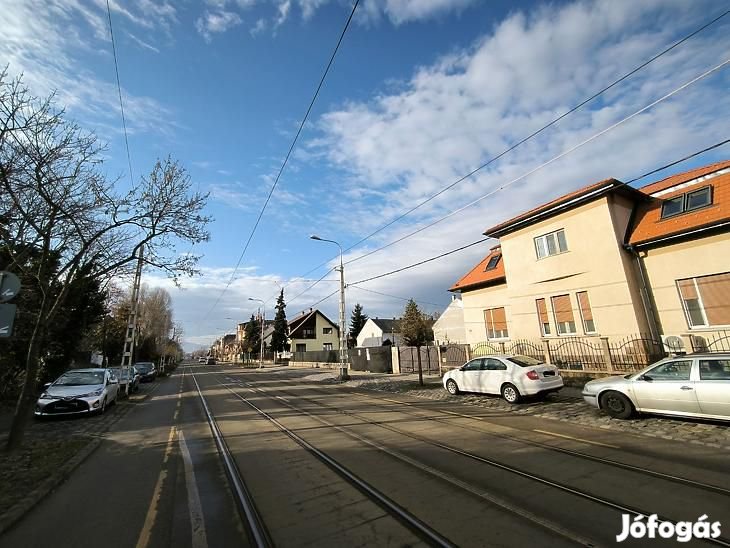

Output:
xmin=642 ymin=233 xmax=730 ymax=335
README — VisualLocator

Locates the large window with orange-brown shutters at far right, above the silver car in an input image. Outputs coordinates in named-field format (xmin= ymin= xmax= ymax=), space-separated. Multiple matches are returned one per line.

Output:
xmin=677 ymin=272 xmax=730 ymax=328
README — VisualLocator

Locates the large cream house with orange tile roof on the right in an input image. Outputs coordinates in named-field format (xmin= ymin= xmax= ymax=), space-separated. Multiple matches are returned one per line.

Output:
xmin=450 ymin=161 xmax=730 ymax=344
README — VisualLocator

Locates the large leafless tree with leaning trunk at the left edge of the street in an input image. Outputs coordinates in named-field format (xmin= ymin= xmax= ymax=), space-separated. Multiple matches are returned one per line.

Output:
xmin=0 ymin=71 xmax=210 ymax=450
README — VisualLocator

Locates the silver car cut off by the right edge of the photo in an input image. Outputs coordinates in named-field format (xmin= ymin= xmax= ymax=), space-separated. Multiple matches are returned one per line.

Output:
xmin=583 ymin=353 xmax=730 ymax=420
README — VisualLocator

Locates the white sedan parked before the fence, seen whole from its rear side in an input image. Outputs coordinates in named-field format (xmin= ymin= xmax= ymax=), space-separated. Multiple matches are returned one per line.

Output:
xmin=443 ymin=355 xmax=563 ymax=403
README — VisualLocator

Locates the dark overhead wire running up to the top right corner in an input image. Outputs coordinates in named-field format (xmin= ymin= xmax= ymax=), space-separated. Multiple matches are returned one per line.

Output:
xmin=280 ymin=10 xmax=730 ymax=282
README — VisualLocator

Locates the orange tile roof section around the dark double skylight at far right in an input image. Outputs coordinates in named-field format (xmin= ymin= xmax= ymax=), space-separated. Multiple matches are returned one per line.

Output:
xmin=628 ymin=167 xmax=730 ymax=245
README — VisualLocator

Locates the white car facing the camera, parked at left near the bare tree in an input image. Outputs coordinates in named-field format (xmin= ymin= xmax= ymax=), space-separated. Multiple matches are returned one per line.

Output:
xmin=35 ymin=369 xmax=119 ymax=418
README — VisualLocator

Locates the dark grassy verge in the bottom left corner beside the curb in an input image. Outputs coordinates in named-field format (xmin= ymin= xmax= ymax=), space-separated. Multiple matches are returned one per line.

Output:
xmin=0 ymin=436 xmax=91 ymax=515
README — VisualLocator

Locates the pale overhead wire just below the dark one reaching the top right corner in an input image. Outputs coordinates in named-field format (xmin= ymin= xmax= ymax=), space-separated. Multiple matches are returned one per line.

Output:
xmin=345 ymin=59 xmax=730 ymax=265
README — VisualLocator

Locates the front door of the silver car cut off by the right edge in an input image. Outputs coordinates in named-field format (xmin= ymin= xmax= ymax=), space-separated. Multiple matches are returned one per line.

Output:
xmin=632 ymin=358 xmax=700 ymax=414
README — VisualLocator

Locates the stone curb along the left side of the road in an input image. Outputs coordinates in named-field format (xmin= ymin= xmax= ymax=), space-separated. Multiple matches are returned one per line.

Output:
xmin=0 ymin=382 xmax=161 ymax=536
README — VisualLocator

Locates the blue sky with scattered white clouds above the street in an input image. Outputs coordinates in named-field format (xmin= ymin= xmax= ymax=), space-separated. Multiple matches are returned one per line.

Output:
xmin=0 ymin=0 xmax=730 ymax=349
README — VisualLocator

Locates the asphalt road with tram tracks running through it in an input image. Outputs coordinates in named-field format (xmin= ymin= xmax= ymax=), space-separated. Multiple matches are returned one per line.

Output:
xmin=0 ymin=365 xmax=730 ymax=548
